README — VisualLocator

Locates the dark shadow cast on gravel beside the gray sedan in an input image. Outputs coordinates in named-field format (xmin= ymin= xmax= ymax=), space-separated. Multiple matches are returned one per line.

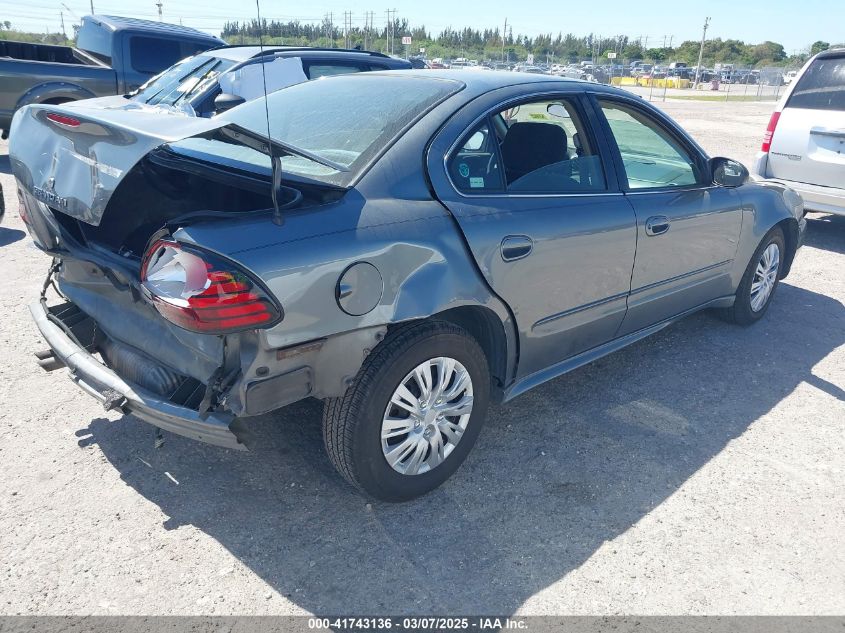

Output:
xmin=80 ymin=262 xmax=845 ymax=614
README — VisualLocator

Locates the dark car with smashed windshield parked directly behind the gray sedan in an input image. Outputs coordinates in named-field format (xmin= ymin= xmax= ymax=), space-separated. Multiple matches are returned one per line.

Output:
xmin=125 ymin=45 xmax=412 ymax=117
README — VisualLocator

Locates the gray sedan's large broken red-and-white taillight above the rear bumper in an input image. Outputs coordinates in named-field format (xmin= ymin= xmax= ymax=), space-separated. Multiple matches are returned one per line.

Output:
xmin=141 ymin=240 xmax=281 ymax=334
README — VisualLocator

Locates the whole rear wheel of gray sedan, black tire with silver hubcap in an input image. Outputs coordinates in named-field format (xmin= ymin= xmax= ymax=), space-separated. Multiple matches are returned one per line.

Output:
xmin=323 ymin=321 xmax=490 ymax=501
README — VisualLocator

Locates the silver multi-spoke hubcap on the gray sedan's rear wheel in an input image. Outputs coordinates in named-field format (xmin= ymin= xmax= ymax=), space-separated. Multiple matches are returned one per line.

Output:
xmin=381 ymin=356 xmax=472 ymax=475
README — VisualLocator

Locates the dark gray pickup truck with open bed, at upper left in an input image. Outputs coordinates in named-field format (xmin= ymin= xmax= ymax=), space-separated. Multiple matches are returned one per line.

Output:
xmin=0 ymin=15 xmax=225 ymax=138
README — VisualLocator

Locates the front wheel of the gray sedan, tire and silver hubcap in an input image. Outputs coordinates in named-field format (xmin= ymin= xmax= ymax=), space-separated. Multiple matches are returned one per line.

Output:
xmin=722 ymin=226 xmax=786 ymax=325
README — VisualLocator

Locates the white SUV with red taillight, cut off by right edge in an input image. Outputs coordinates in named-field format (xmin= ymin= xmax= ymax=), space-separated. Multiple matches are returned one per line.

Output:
xmin=751 ymin=48 xmax=845 ymax=215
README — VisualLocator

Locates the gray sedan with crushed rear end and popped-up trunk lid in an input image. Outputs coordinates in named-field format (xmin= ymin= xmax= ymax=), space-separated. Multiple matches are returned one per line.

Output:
xmin=10 ymin=71 xmax=805 ymax=500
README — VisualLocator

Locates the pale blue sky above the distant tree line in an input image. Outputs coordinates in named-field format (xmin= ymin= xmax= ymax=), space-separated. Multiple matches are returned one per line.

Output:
xmin=0 ymin=0 xmax=845 ymax=53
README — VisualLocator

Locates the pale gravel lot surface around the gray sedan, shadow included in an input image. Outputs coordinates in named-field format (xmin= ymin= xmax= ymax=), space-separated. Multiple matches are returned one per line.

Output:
xmin=0 ymin=102 xmax=845 ymax=614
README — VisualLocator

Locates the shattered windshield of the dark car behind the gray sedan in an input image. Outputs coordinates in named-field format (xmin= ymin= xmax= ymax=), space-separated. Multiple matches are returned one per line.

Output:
xmin=133 ymin=55 xmax=235 ymax=105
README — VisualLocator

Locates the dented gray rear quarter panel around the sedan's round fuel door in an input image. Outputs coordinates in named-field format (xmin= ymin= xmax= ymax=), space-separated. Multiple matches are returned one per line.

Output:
xmin=174 ymin=191 xmax=516 ymax=382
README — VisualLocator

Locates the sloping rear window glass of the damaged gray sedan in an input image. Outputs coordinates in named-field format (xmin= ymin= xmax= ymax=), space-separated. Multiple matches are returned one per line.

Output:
xmin=211 ymin=74 xmax=463 ymax=186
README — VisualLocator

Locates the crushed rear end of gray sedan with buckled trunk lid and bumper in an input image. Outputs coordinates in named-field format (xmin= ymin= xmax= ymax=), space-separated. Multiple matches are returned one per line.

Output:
xmin=10 ymin=103 xmax=342 ymax=449
